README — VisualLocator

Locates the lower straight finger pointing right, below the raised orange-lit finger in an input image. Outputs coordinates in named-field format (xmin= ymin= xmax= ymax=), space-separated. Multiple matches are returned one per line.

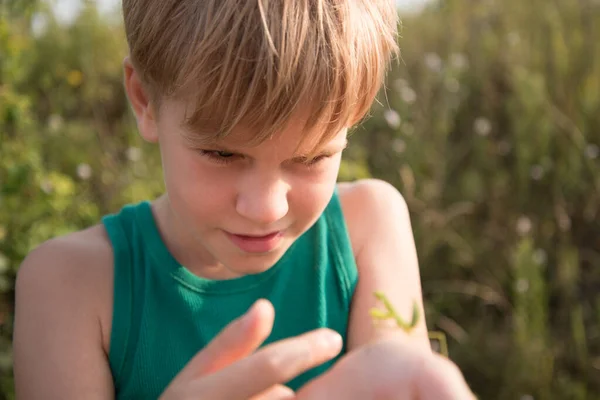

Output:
xmin=198 ymin=329 xmax=342 ymax=399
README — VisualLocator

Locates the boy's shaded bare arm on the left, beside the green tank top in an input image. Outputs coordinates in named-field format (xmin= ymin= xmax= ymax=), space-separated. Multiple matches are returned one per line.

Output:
xmin=13 ymin=234 xmax=114 ymax=400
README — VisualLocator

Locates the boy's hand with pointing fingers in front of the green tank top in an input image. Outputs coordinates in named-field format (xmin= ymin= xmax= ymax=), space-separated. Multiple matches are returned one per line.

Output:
xmin=160 ymin=300 xmax=342 ymax=400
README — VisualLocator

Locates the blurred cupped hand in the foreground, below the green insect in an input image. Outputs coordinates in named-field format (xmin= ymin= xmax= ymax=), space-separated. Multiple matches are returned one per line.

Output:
xmin=297 ymin=333 xmax=475 ymax=400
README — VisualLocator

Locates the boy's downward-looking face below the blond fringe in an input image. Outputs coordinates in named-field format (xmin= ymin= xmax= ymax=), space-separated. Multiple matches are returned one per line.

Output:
xmin=156 ymin=98 xmax=347 ymax=275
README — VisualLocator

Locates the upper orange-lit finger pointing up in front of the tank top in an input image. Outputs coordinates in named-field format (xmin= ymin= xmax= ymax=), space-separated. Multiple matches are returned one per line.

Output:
xmin=181 ymin=299 xmax=275 ymax=379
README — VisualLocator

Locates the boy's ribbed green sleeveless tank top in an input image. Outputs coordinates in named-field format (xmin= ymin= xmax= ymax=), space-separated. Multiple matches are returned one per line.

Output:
xmin=102 ymin=190 xmax=358 ymax=399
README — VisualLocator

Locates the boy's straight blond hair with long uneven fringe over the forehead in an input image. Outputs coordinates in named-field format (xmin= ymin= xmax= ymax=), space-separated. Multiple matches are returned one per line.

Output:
xmin=123 ymin=0 xmax=398 ymax=150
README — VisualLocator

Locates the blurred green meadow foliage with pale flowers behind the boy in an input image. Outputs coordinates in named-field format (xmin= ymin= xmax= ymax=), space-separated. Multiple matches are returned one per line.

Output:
xmin=0 ymin=0 xmax=600 ymax=400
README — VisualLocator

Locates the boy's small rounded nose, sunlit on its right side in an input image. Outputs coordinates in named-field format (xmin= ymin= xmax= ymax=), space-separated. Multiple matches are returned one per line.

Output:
xmin=236 ymin=174 xmax=289 ymax=227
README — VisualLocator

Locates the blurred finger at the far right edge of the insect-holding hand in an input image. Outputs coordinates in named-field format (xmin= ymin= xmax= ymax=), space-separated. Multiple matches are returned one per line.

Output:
xmin=418 ymin=354 xmax=476 ymax=400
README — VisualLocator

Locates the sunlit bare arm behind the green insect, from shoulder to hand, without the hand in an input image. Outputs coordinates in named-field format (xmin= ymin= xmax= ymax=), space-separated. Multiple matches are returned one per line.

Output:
xmin=342 ymin=180 xmax=430 ymax=350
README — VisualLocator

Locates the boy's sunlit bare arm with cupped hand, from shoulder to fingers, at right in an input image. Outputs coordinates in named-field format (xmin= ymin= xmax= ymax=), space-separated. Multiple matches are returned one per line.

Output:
xmin=296 ymin=180 xmax=475 ymax=400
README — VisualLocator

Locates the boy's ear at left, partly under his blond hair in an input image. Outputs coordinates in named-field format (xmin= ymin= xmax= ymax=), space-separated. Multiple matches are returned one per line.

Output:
xmin=123 ymin=57 xmax=158 ymax=143
